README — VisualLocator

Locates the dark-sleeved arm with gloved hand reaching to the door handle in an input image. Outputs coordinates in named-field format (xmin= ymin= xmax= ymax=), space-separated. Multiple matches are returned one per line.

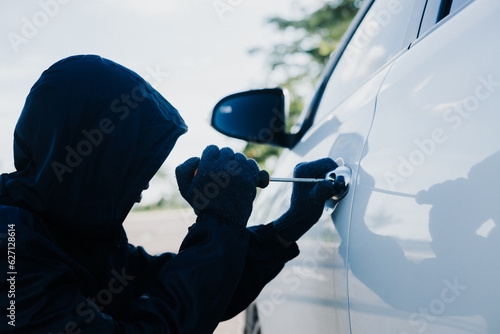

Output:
xmin=224 ymin=158 xmax=343 ymax=319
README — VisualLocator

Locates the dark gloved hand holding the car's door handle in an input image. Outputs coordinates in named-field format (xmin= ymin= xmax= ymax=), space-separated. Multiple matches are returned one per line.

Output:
xmin=273 ymin=158 xmax=344 ymax=241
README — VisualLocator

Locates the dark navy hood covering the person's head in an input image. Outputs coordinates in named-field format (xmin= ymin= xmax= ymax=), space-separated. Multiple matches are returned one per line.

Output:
xmin=0 ymin=55 xmax=187 ymax=237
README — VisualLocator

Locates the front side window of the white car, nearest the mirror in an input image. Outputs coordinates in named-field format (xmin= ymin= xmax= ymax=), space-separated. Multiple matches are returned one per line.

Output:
xmin=316 ymin=0 xmax=414 ymax=120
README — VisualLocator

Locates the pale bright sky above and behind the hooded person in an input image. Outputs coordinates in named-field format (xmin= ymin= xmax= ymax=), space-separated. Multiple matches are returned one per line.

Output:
xmin=0 ymin=0 xmax=323 ymax=205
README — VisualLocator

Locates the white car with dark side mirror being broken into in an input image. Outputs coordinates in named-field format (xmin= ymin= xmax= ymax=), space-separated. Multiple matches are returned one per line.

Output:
xmin=212 ymin=0 xmax=500 ymax=334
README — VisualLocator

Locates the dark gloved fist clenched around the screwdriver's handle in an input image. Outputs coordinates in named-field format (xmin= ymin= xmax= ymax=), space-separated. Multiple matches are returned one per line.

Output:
xmin=175 ymin=145 xmax=259 ymax=226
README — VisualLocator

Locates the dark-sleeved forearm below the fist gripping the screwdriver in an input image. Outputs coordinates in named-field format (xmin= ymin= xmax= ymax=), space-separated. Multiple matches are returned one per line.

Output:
xmin=118 ymin=215 xmax=248 ymax=333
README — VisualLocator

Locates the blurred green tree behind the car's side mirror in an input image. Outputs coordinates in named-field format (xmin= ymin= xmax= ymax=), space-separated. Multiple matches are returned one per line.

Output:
xmin=244 ymin=0 xmax=362 ymax=169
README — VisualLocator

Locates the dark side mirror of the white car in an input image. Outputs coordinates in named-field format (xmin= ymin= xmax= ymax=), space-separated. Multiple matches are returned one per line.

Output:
xmin=211 ymin=88 xmax=289 ymax=147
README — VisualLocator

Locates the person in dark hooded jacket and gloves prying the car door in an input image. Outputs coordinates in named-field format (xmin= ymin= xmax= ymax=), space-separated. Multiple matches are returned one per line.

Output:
xmin=0 ymin=55 xmax=342 ymax=334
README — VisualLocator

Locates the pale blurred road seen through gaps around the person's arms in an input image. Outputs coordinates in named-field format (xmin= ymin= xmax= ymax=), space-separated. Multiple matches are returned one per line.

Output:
xmin=123 ymin=209 xmax=244 ymax=334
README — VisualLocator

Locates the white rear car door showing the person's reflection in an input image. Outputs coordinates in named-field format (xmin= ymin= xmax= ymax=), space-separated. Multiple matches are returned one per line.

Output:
xmin=347 ymin=0 xmax=500 ymax=334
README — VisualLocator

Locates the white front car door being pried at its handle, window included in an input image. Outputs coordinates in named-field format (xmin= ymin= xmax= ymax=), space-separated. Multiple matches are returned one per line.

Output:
xmin=251 ymin=0 xmax=423 ymax=334
